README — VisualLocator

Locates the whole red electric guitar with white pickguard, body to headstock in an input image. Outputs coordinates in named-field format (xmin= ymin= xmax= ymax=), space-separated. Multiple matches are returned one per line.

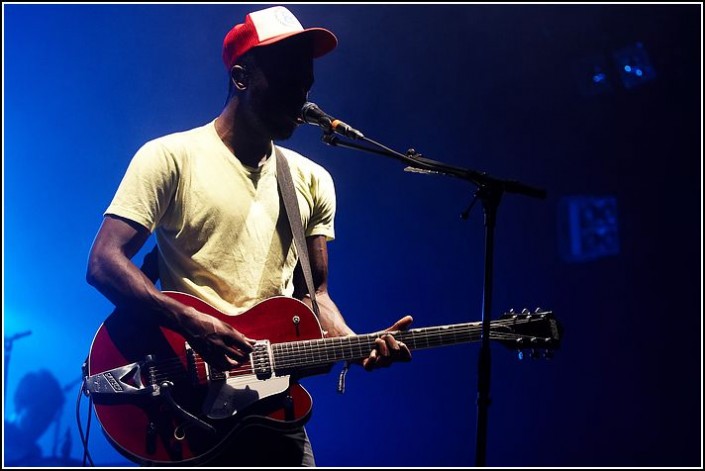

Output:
xmin=84 ymin=291 xmax=560 ymax=465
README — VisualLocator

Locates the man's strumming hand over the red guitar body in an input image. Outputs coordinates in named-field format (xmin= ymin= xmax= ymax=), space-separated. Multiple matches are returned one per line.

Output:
xmin=178 ymin=307 xmax=255 ymax=371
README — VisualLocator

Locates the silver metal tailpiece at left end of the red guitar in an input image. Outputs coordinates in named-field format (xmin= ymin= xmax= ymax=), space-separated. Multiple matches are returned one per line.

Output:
xmin=84 ymin=358 xmax=159 ymax=396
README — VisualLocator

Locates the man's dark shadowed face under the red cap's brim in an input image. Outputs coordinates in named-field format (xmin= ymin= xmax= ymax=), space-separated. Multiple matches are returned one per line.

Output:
xmin=248 ymin=38 xmax=313 ymax=140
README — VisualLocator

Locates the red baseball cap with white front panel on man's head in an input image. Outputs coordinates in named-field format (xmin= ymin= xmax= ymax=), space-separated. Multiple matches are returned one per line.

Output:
xmin=223 ymin=7 xmax=338 ymax=71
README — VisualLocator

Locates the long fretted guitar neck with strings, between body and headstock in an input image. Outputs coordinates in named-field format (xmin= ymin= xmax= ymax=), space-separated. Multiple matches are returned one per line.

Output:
xmin=272 ymin=321 xmax=492 ymax=371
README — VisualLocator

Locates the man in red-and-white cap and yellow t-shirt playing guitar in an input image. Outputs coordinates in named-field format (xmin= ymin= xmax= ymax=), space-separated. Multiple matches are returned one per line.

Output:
xmin=87 ymin=7 xmax=412 ymax=466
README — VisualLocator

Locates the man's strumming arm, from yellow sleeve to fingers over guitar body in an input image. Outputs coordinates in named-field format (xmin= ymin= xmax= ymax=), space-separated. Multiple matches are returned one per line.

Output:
xmin=86 ymin=216 xmax=254 ymax=370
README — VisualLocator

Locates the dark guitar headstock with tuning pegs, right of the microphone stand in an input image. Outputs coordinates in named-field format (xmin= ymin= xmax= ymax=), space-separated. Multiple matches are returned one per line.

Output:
xmin=490 ymin=308 xmax=563 ymax=360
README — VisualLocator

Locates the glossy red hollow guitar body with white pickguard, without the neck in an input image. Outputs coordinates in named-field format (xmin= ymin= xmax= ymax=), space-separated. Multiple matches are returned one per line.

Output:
xmin=86 ymin=291 xmax=323 ymax=465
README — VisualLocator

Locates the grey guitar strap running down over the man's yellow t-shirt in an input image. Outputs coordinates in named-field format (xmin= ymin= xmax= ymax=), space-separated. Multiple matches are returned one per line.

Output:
xmin=272 ymin=148 xmax=321 ymax=319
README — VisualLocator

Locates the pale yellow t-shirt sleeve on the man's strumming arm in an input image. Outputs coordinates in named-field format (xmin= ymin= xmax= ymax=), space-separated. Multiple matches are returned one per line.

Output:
xmin=104 ymin=141 xmax=178 ymax=232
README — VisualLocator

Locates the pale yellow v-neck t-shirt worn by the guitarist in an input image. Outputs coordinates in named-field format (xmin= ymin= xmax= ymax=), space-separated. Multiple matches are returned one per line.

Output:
xmin=105 ymin=120 xmax=335 ymax=315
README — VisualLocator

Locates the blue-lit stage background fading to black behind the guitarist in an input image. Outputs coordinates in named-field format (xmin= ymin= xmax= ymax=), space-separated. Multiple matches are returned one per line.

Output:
xmin=3 ymin=4 xmax=702 ymax=467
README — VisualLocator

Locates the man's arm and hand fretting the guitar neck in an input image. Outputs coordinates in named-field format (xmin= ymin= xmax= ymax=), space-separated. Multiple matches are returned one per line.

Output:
xmin=295 ymin=235 xmax=413 ymax=370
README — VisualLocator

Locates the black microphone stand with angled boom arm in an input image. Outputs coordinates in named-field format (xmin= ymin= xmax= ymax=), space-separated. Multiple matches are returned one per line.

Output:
xmin=321 ymin=131 xmax=546 ymax=466
